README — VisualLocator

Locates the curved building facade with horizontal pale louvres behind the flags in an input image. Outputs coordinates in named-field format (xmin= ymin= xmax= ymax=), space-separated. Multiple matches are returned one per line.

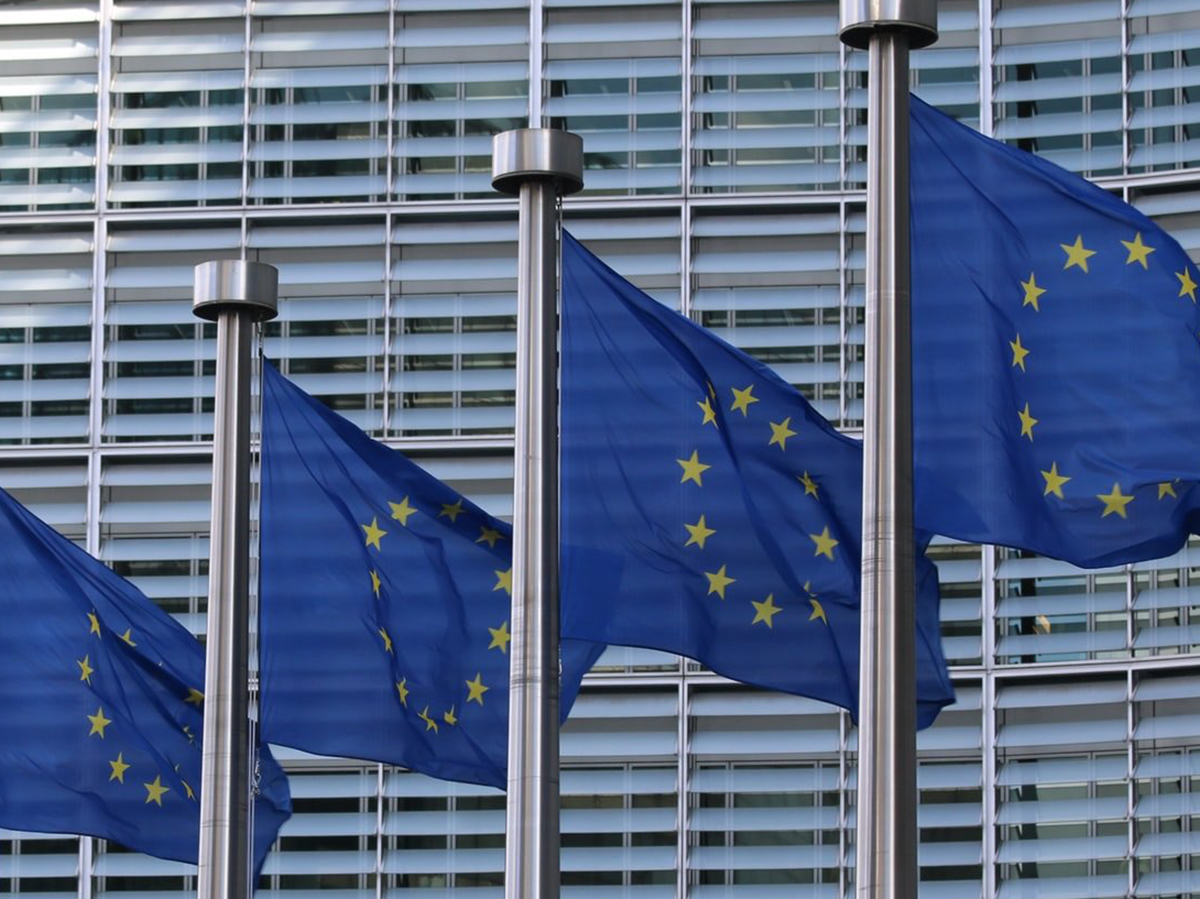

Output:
xmin=0 ymin=0 xmax=1200 ymax=899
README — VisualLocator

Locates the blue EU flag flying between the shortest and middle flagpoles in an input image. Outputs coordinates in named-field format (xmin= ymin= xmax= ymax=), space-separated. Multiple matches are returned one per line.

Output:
xmin=260 ymin=362 xmax=604 ymax=787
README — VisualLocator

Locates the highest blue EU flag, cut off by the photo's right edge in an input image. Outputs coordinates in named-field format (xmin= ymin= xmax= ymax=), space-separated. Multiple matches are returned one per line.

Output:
xmin=911 ymin=97 xmax=1200 ymax=567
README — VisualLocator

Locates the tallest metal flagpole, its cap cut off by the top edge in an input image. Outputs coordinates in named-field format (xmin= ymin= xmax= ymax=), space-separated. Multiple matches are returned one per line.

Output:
xmin=840 ymin=0 xmax=937 ymax=899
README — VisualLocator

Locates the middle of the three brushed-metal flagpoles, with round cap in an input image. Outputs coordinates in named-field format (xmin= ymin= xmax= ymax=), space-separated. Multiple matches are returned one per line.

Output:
xmin=492 ymin=128 xmax=583 ymax=899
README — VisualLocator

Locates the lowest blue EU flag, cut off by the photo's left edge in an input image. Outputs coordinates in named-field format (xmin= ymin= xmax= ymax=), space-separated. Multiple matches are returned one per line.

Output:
xmin=0 ymin=491 xmax=292 ymax=869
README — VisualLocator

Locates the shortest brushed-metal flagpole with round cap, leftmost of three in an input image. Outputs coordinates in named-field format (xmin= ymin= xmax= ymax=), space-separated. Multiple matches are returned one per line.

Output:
xmin=192 ymin=259 xmax=278 ymax=899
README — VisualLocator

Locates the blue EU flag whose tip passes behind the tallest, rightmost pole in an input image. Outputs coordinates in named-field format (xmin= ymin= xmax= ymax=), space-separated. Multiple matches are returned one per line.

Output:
xmin=562 ymin=234 xmax=954 ymax=725
